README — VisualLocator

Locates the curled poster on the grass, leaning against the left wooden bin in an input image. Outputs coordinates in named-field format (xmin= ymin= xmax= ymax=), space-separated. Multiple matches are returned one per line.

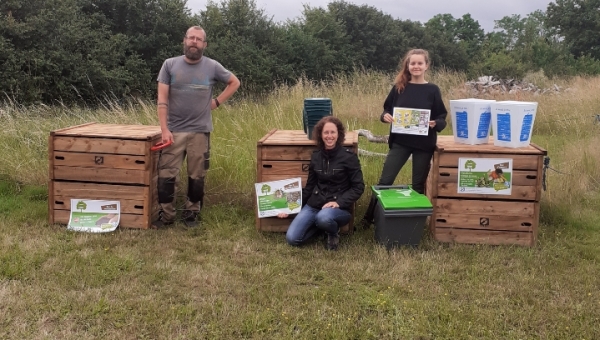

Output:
xmin=67 ymin=199 xmax=121 ymax=233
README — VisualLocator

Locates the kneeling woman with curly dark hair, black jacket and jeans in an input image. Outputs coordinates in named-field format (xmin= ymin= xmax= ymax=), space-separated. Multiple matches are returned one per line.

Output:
xmin=278 ymin=116 xmax=365 ymax=250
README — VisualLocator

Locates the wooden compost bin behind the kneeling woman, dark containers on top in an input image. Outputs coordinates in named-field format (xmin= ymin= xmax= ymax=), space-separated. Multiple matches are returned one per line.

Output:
xmin=256 ymin=129 xmax=358 ymax=233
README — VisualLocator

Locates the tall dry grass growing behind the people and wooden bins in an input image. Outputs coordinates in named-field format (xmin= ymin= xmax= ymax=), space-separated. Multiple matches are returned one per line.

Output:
xmin=0 ymin=70 xmax=600 ymax=215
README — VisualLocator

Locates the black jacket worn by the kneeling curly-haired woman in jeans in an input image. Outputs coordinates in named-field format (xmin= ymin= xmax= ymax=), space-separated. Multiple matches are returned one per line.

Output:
xmin=302 ymin=146 xmax=365 ymax=210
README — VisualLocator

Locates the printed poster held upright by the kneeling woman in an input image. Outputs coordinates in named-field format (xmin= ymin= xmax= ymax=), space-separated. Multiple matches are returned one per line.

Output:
xmin=254 ymin=177 xmax=302 ymax=218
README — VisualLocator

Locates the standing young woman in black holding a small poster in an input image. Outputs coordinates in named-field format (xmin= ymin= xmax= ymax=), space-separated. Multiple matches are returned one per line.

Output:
xmin=362 ymin=49 xmax=448 ymax=228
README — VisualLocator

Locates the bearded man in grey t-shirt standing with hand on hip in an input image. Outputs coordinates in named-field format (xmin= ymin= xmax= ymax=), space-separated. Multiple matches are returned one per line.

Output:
xmin=152 ymin=26 xmax=240 ymax=228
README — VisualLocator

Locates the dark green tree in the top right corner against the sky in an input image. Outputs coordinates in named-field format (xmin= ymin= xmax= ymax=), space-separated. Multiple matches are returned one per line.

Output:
xmin=546 ymin=0 xmax=600 ymax=59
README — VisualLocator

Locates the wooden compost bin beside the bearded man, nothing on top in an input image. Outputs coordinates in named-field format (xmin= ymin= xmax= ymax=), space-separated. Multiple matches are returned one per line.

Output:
xmin=48 ymin=123 xmax=161 ymax=229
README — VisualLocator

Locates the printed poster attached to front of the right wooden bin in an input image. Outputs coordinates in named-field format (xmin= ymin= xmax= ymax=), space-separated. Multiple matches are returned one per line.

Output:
xmin=458 ymin=158 xmax=513 ymax=195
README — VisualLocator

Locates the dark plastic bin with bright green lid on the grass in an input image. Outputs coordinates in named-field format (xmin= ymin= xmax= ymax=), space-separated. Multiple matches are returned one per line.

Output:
xmin=372 ymin=185 xmax=433 ymax=249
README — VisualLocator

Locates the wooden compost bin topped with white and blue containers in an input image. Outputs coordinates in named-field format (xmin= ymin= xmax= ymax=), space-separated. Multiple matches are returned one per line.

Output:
xmin=426 ymin=136 xmax=546 ymax=246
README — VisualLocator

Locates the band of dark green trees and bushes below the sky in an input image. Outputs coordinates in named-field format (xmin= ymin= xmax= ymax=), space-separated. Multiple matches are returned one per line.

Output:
xmin=0 ymin=0 xmax=600 ymax=104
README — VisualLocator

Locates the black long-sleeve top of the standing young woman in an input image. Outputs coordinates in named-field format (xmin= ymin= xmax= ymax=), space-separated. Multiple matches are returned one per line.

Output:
xmin=381 ymin=83 xmax=448 ymax=151
